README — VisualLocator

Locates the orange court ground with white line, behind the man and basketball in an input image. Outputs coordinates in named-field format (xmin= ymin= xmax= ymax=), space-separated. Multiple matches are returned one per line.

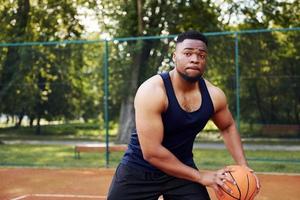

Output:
xmin=0 ymin=168 xmax=300 ymax=200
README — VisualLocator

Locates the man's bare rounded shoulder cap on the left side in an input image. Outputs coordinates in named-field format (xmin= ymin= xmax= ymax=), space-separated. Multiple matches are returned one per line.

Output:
xmin=134 ymin=75 xmax=167 ymax=112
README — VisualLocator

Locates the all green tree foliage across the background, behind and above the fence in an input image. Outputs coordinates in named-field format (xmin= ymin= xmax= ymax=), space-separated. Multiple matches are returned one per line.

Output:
xmin=0 ymin=0 xmax=300 ymax=138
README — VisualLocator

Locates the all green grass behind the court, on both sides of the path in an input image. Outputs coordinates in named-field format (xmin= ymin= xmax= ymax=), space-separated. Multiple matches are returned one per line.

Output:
xmin=0 ymin=123 xmax=300 ymax=173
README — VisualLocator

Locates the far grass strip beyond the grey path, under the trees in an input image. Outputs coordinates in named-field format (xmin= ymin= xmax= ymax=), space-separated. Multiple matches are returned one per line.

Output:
xmin=0 ymin=121 xmax=300 ymax=145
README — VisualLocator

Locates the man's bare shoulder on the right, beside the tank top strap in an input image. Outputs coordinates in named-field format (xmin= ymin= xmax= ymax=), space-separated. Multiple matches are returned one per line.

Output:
xmin=204 ymin=79 xmax=227 ymax=112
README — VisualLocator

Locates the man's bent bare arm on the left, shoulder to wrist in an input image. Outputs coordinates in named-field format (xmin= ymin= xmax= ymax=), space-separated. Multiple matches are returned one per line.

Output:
xmin=134 ymin=77 xmax=201 ymax=182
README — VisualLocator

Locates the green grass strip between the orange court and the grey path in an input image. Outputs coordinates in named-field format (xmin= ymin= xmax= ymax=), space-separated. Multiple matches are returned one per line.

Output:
xmin=0 ymin=145 xmax=300 ymax=173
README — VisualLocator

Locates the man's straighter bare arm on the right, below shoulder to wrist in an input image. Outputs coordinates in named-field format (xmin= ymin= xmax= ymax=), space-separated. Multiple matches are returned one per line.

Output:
xmin=212 ymin=86 xmax=248 ymax=166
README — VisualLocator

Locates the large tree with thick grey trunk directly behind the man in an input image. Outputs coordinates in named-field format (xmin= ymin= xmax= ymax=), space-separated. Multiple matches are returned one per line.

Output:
xmin=102 ymin=0 xmax=220 ymax=143
